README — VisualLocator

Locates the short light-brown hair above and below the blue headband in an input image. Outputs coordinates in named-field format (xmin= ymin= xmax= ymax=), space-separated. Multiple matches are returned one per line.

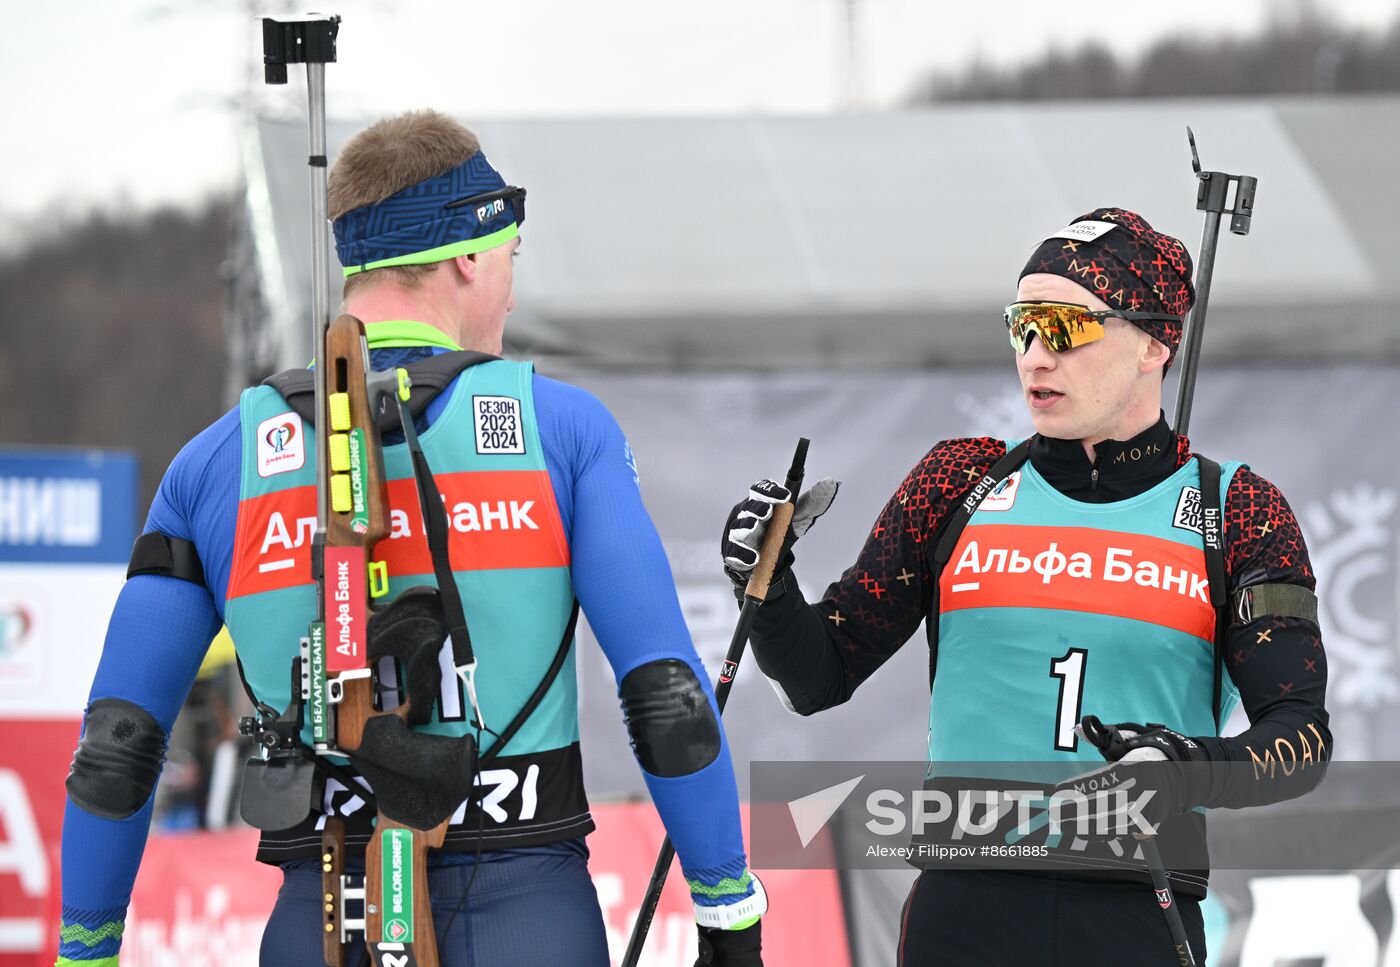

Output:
xmin=326 ymin=109 xmax=482 ymax=295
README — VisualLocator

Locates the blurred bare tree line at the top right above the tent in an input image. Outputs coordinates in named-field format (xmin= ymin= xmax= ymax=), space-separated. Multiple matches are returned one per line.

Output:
xmin=913 ymin=0 xmax=1400 ymax=102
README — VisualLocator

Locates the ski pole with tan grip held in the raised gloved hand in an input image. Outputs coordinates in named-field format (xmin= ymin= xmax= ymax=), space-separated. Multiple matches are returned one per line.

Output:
xmin=622 ymin=437 xmax=811 ymax=967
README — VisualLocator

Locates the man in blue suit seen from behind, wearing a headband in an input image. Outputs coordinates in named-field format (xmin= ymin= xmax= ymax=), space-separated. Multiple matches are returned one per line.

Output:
xmin=59 ymin=112 xmax=767 ymax=967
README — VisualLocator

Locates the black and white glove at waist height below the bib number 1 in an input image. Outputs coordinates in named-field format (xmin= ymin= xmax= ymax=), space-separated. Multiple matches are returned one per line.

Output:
xmin=1056 ymin=715 xmax=1210 ymax=835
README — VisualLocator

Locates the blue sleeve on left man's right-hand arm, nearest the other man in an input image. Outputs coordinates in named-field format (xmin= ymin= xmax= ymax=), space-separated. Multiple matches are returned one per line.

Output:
xmin=535 ymin=376 xmax=753 ymax=905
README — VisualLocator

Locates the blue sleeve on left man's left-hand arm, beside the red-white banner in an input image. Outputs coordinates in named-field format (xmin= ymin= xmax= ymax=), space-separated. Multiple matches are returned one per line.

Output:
xmin=59 ymin=411 xmax=238 ymax=963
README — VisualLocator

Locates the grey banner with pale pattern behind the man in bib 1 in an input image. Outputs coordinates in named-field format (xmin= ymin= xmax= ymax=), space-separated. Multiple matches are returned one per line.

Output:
xmin=567 ymin=363 xmax=1400 ymax=795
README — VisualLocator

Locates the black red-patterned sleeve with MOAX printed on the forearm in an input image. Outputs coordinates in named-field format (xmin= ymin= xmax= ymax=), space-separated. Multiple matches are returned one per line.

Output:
xmin=1200 ymin=470 xmax=1333 ymax=806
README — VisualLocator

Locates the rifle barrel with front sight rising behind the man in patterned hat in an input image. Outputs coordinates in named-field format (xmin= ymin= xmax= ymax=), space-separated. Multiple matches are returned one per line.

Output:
xmin=1172 ymin=126 xmax=1259 ymax=437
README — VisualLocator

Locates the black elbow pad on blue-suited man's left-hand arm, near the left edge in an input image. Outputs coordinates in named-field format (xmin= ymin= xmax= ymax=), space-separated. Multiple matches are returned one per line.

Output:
xmin=64 ymin=698 xmax=167 ymax=819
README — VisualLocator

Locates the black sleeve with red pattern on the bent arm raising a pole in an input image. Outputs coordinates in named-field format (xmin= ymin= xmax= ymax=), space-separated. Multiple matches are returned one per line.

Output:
xmin=750 ymin=438 xmax=1007 ymax=715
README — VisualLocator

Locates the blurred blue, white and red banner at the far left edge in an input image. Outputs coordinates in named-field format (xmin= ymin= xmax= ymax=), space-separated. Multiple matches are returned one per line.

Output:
xmin=0 ymin=449 xmax=136 ymax=967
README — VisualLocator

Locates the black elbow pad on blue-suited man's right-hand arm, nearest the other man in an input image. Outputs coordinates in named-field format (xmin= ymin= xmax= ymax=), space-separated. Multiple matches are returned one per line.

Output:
xmin=619 ymin=658 xmax=720 ymax=778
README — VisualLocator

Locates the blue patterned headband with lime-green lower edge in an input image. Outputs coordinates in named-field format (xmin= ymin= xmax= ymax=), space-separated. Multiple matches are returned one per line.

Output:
xmin=333 ymin=151 xmax=525 ymax=276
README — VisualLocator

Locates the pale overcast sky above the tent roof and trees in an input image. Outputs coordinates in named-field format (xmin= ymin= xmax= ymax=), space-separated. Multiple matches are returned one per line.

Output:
xmin=0 ymin=0 xmax=1400 ymax=248
